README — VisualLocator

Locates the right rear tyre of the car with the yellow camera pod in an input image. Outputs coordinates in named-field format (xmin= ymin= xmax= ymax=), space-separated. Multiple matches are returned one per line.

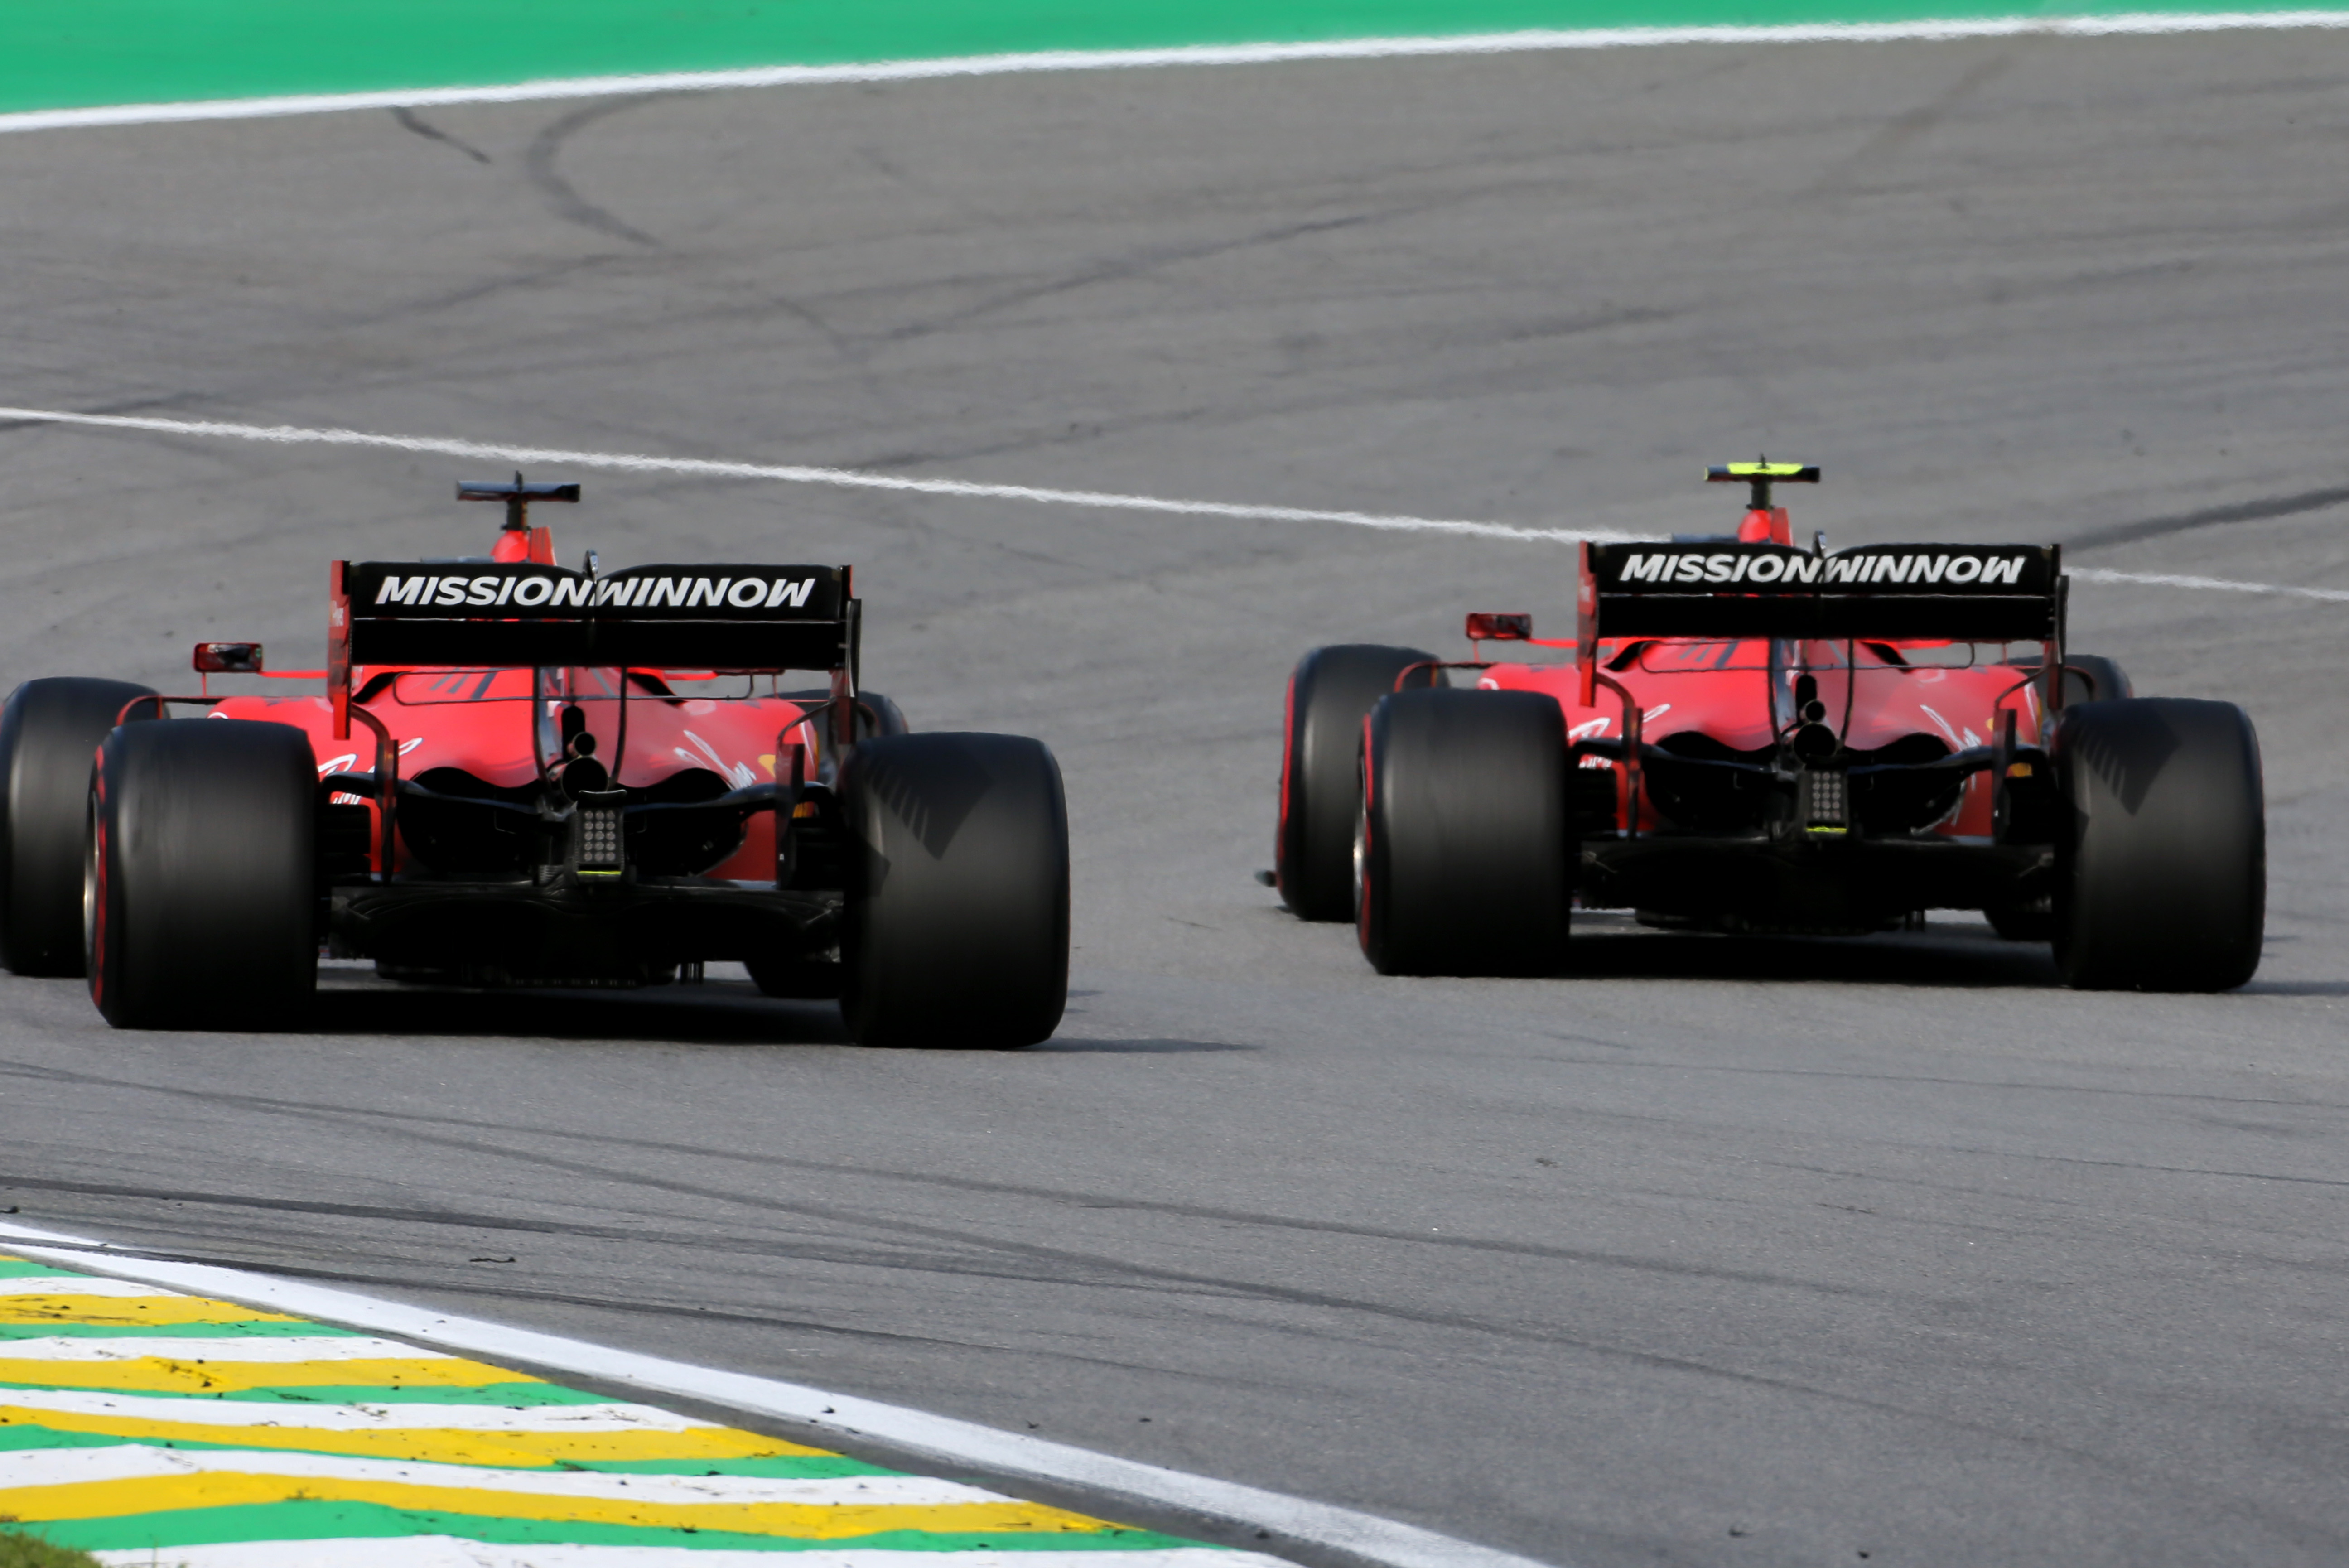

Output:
xmin=2053 ymin=697 xmax=2267 ymax=990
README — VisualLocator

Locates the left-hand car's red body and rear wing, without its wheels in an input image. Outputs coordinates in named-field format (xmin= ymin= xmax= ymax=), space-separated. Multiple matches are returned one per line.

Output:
xmin=134 ymin=474 xmax=878 ymax=995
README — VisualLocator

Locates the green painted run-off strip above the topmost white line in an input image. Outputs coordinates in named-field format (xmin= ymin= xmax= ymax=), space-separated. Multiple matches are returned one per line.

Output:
xmin=0 ymin=0 xmax=2320 ymax=113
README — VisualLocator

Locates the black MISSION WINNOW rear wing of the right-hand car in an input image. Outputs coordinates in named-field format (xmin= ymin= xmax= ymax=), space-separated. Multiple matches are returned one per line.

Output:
xmin=1576 ymin=545 xmax=2065 ymax=707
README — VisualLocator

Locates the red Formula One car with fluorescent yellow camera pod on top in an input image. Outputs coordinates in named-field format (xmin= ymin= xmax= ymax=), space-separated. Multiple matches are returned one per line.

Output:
xmin=1273 ymin=463 xmax=2267 ymax=990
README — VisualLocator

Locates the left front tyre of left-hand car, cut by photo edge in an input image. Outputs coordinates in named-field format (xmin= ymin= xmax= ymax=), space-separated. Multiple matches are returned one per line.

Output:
xmin=0 ymin=676 xmax=155 ymax=974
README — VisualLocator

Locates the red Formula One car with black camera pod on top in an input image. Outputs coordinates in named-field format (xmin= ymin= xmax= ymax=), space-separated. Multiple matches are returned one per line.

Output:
xmin=0 ymin=474 xmax=1069 ymax=1045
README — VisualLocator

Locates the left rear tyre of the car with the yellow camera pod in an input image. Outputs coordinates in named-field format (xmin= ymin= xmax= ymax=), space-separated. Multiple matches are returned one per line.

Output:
xmin=1355 ymin=690 xmax=1578 ymax=974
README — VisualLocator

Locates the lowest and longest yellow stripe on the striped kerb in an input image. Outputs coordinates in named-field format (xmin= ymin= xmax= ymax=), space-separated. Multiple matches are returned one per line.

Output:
xmin=7 ymin=1474 xmax=1114 ymax=1540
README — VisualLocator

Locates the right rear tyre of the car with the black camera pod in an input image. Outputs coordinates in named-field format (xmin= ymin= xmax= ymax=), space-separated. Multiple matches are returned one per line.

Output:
xmin=839 ymin=733 xmax=1069 ymax=1049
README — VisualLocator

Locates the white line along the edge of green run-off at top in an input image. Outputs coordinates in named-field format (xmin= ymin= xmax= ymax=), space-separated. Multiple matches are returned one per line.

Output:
xmin=14 ymin=12 xmax=2349 ymax=131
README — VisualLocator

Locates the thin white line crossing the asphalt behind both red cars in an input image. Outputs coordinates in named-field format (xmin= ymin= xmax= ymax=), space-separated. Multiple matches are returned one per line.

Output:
xmin=0 ymin=409 xmax=2349 ymax=603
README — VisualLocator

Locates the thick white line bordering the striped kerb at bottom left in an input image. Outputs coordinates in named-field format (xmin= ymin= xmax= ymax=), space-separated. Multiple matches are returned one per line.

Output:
xmin=0 ymin=1223 xmax=1569 ymax=1568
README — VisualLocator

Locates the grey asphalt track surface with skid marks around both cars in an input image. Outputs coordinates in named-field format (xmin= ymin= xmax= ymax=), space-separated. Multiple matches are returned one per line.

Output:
xmin=0 ymin=35 xmax=2349 ymax=1563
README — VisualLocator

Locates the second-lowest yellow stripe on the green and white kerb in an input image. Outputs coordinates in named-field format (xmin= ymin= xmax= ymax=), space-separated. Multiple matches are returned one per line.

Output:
xmin=0 ymin=1397 xmax=829 ymax=1469
